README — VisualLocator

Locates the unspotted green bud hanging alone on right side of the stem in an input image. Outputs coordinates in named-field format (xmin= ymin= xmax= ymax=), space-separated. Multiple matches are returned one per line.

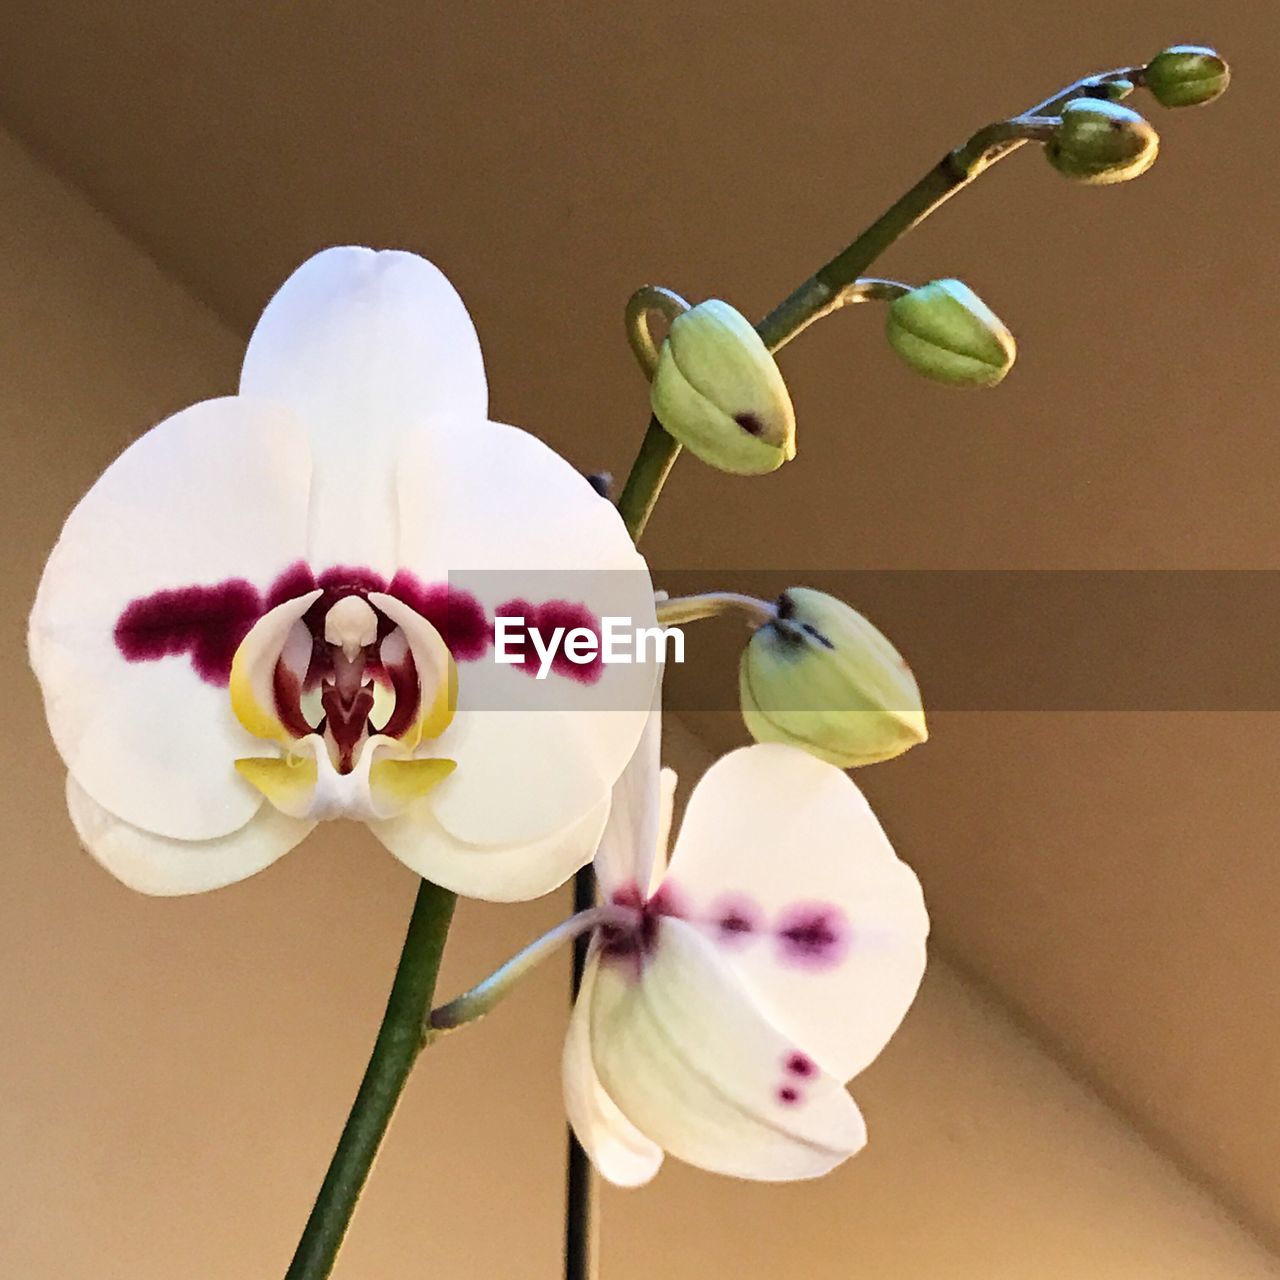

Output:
xmin=886 ymin=280 xmax=1018 ymax=387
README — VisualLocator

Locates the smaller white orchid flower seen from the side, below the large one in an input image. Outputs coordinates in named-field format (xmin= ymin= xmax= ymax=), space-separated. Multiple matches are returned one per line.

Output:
xmin=563 ymin=718 xmax=928 ymax=1185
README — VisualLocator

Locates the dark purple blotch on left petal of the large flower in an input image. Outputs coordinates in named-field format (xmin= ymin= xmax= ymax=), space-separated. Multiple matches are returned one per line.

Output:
xmin=114 ymin=579 xmax=262 ymax=686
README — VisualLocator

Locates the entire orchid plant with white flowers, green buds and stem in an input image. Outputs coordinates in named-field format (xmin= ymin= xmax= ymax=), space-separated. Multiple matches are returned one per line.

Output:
xmin=29 ymin=37 xmax=1228 ymax=1280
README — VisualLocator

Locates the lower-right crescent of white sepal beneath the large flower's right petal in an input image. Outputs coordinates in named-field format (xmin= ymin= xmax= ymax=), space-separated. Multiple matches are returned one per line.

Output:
xmin=369 ymin=788 xmax=609 ymax=902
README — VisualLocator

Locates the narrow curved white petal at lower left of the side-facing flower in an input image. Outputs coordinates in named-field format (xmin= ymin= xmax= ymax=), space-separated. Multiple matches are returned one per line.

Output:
xmin=561 ymin=956 xmax=662 ymax=1187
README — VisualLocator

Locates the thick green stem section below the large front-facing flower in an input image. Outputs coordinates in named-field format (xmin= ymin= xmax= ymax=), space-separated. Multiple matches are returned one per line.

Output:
xmin=284 ymin=881 xmax=456 ymax=1280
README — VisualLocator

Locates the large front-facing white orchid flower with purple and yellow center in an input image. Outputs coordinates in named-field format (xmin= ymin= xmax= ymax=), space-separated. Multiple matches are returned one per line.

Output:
xmin=29 ymin=241 xmax=653 ymax=900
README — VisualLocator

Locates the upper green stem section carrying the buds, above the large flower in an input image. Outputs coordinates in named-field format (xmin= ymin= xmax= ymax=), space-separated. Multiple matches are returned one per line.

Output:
xmin=618 ymin=67 xmax=1144 ymax=541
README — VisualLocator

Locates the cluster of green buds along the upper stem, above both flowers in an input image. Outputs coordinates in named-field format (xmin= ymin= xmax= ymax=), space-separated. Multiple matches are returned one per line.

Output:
xmin=640 ymin=45 xmax=1230 ymax=475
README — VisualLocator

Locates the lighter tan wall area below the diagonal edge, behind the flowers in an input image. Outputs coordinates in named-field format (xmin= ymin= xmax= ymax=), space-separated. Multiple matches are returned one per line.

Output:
xmin=0 ymin=115 xmax=1280 ymax=1280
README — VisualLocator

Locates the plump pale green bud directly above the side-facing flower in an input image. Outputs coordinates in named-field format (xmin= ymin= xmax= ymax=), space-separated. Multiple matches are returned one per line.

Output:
xmin=739 ymin=586 xmax=929 ymax=769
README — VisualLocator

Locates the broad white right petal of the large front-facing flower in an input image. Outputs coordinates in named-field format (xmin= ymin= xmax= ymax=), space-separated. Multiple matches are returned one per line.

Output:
xmin=398 ymin=422 xmax=658 ymax=844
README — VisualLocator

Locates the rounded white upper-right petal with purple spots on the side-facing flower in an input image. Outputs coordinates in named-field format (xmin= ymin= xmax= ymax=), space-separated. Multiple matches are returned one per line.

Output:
xmin=667 ymin=745 xmax=929 ymax=1079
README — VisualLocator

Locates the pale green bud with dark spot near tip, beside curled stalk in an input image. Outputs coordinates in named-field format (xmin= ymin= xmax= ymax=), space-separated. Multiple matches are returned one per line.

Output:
xmin=649 ymin=298 xmax=796 ymax=475
